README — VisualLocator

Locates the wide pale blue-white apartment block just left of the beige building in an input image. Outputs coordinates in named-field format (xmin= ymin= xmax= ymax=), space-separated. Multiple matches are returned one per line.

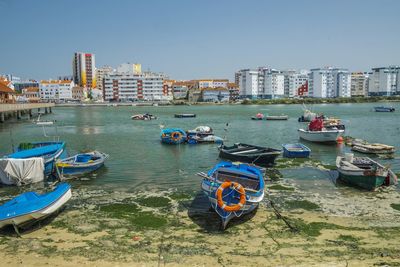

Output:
xmin=308 ymin=67 xmax=351 ymax=98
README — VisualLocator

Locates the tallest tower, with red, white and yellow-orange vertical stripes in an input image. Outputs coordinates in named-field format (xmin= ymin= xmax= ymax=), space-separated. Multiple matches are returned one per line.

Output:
xmin=72 ymin=52 xmax=96 ymax=88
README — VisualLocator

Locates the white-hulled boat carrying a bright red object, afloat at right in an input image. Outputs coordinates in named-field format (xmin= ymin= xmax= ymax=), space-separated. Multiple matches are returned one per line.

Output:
xmin=297 ymin=118 xmax=344 ymax=143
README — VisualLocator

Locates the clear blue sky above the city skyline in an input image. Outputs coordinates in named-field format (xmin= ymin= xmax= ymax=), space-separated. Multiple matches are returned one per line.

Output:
xmin=0 ymin=0 xmax=400 ymax=80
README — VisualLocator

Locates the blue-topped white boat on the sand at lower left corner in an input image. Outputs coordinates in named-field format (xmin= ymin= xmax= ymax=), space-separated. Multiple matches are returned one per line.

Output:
xmin=0 ymin=183 xmax=72 ymax=233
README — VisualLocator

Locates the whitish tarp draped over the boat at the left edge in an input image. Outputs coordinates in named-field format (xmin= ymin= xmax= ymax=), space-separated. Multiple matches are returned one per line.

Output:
xmin=0 ymin=157 xmax=44 ymax=186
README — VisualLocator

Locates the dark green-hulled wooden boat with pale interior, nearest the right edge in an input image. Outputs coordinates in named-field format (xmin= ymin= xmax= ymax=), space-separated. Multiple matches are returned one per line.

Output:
xmin=336 ymin=154 xmax=390 ymax=190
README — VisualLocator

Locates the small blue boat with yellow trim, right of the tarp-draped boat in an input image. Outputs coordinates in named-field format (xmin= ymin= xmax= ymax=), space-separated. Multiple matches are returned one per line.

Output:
xmin=56 ymin=151 xmax=108 ymax=175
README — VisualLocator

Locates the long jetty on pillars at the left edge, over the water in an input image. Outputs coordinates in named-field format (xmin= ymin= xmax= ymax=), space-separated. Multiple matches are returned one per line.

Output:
xmin=0 ymin=103 xmax=54 ymax=123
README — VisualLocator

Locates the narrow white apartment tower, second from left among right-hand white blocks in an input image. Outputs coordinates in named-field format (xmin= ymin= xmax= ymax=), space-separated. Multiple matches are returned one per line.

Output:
xmin=263 ymin=69 xmax=285 ymax=99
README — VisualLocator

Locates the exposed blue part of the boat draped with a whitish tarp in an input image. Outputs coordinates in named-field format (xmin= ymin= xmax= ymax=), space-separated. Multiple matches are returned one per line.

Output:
xmin=6 ymin=142 xmax=66 ymax=176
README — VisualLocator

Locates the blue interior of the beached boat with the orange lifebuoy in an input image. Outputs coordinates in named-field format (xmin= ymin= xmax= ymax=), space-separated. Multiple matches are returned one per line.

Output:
xmin=213 ymin=168 xmax=260 ymax=191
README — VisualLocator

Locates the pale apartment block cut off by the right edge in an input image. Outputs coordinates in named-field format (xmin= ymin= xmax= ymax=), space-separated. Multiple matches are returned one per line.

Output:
xmin=368 ymin=66 xmax=400 ymax=96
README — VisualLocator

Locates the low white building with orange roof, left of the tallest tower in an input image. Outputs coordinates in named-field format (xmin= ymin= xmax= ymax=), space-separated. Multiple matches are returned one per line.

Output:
xmin=39 ymin=80 xmax=74 ymax=102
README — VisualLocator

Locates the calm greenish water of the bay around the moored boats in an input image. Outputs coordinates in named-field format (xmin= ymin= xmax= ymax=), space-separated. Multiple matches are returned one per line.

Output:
xmin=0 ymin=103 xmax=400 ymax=196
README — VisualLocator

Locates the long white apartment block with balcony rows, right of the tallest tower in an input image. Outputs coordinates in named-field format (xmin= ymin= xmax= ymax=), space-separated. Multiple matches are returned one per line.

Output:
xmin=103 ymin=71 xmax=172 ymax=101
